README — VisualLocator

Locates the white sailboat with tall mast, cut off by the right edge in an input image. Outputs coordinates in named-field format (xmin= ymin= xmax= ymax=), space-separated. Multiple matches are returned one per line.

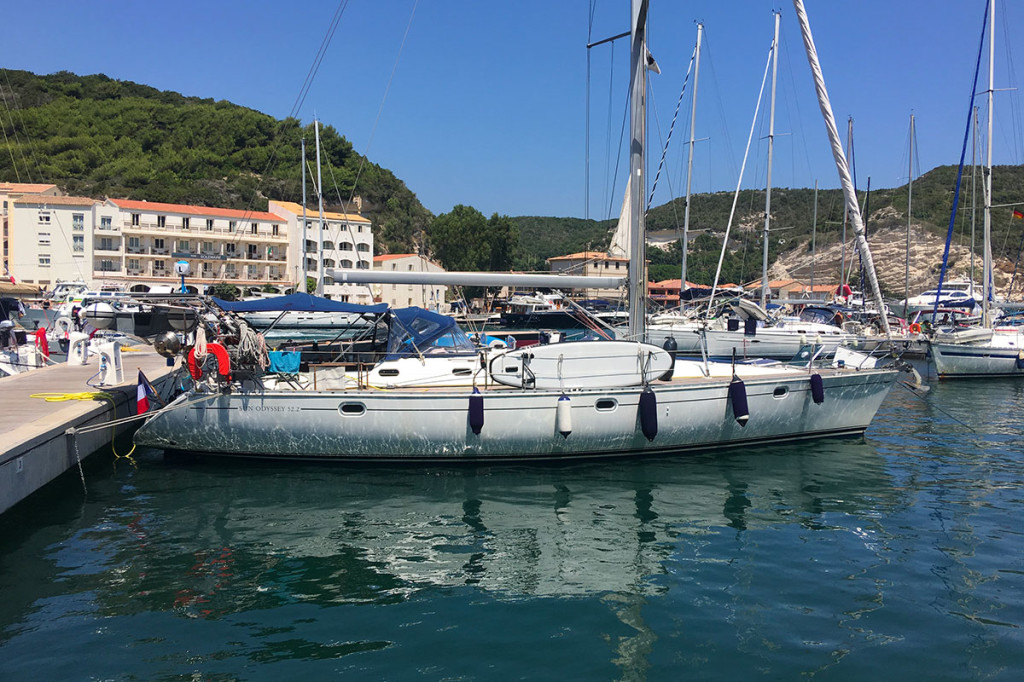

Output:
xmin=930 ymin=0 xmax=1024 ymax=379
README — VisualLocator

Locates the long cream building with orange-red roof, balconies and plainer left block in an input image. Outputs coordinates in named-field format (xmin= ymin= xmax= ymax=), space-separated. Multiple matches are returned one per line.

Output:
xmin=10 ymin=197 xmax=292 ymax=292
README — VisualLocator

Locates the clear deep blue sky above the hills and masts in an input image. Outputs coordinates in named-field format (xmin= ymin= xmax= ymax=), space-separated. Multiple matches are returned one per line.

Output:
xmin=0 ymin=0 xmax=1024 ymax=218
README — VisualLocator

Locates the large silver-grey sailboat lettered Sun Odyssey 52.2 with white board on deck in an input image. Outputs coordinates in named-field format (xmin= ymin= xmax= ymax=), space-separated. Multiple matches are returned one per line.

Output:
xmin=135 ymin=0 xmax=898 ymax=462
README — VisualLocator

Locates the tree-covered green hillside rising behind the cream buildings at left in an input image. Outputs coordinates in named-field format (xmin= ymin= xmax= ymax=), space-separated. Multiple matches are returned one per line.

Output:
xmin=0 ymin=71 xmax=430 ymax=251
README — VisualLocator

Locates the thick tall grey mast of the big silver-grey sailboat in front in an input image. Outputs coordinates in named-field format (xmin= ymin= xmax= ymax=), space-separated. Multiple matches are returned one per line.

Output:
xmin=629 ymin=0 xmax=648 ymax=341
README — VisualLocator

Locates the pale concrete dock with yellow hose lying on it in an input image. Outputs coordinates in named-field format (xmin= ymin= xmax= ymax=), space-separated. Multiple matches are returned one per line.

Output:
xmin=0 ymin=346 xmax=172 ymax=513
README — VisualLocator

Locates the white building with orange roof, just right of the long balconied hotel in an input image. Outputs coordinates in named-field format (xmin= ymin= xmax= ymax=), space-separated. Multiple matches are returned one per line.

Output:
xmin=268 ymin=201 xmax=374 ymax=304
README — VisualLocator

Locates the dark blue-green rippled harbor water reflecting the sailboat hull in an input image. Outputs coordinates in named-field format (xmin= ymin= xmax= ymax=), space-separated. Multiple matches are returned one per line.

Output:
xmin=0 ymin=380 xmax=1024 ymax=680
